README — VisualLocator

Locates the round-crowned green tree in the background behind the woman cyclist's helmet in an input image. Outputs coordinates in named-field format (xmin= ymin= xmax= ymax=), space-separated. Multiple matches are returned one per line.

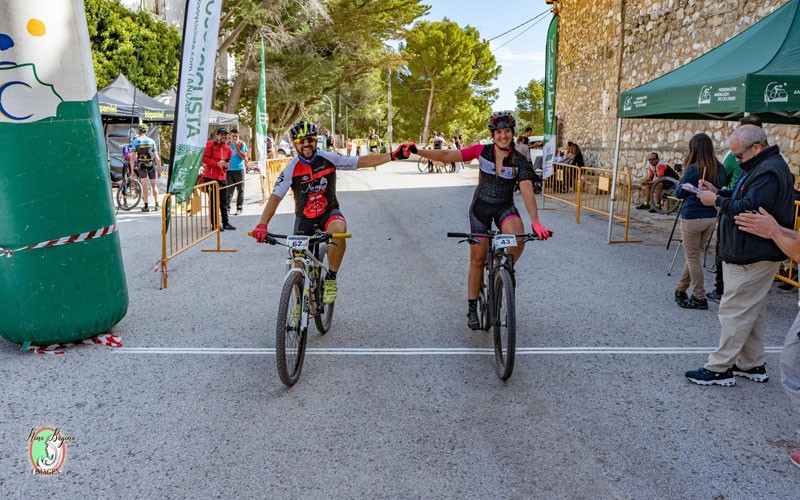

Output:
xmin=396 ymin=18 xmax=501 ymax=142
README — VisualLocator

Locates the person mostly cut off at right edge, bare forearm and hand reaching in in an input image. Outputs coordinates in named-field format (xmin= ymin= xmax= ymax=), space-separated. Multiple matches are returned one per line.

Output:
xmin=734 ymin=207 xmax=800 ymax=467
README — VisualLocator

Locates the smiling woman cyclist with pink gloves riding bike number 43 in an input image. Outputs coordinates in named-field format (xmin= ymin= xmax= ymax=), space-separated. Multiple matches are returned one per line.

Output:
xmin=411 ymin=111 xmax=553 ymax=330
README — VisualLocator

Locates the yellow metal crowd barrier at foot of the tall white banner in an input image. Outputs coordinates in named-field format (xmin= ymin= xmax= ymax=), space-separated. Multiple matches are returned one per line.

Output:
xmin=159 ymin=181 xmax=236 ymax=288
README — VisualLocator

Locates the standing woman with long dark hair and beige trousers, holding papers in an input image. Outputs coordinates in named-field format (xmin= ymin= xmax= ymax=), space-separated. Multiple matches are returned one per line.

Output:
xmin=675 ymin=133 xmax=725 ymax=309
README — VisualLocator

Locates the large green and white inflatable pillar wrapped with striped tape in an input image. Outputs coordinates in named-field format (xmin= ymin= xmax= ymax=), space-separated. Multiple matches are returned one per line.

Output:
xmin=0 ymin=0 xmax=128 ymax=345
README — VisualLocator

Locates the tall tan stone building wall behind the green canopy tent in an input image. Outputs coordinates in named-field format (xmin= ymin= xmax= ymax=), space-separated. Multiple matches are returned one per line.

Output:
xmin=548 ymin=0 xmax=800 ymax=181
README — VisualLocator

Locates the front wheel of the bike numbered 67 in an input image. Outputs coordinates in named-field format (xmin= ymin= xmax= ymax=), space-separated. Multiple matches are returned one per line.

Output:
xmin=275 ymin=273 xmax=307 ymax=386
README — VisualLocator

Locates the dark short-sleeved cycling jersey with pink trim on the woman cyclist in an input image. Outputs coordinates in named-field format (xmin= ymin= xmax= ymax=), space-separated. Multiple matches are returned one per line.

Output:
xmin=461 ymin=144 xmax=533 ymax=205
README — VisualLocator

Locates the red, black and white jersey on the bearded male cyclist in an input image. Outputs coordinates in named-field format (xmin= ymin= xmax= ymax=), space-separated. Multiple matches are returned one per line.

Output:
xmin=272 ymin=150 xmax=358 ymax=219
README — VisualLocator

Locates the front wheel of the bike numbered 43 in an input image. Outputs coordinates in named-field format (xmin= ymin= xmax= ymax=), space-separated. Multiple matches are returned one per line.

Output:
xmin=492 ymin=269 xmax=517 ymax=380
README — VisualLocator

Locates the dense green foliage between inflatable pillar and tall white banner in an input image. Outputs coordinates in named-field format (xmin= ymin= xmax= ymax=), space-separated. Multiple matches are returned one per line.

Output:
xmin=84 ymin=0 xmax=181 ymax=96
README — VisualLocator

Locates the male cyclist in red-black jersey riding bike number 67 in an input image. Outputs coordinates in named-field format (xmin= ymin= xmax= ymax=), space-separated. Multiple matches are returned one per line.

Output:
xmin=252 ymin=120 xmax=410 ymax=304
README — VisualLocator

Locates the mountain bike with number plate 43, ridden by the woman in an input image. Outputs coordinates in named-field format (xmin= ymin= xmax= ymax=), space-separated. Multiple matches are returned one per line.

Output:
xmin=447 ymin=230 xmax=539 ymax=380
